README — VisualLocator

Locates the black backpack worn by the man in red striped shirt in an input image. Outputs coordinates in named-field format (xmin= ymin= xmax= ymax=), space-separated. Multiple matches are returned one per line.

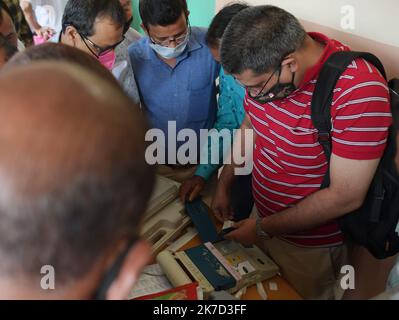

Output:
xmin=312 ymin=51 xmax=399 ymax=259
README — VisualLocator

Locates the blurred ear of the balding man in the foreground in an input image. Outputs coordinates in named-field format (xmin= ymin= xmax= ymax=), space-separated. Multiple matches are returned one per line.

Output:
xmin=107 ymin=240 xmax=152 ymax=300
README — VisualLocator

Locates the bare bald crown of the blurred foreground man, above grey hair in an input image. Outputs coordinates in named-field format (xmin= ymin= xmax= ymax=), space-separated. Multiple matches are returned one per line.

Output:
xmin=0 ymin=63 xmax=144 ymax=194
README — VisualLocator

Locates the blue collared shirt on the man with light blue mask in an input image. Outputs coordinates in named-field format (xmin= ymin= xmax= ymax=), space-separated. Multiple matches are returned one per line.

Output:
xmin=129 ymin=27 xmax=220 ymax=161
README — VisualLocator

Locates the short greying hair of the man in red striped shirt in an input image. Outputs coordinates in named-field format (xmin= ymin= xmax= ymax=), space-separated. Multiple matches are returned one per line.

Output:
xmin=221 ymin=5 xmax=306 ymax=74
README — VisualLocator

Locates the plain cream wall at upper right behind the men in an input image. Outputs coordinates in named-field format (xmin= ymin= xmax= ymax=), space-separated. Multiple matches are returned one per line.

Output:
xmin=216 ymin=0 xmax=399 ymax=77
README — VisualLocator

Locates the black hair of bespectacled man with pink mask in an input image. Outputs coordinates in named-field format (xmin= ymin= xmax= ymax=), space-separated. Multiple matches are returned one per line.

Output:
xmin=62 ymin=0 xmax=126 ymax=37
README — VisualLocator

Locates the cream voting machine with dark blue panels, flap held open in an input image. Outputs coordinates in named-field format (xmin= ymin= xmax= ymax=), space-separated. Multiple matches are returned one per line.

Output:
xmin=157 ymin=199 xmax=279 ymax=299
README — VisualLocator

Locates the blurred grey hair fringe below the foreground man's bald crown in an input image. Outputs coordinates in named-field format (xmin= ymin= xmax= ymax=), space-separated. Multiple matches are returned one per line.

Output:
xmin=0 ymin=168 xmax=152 ymax=286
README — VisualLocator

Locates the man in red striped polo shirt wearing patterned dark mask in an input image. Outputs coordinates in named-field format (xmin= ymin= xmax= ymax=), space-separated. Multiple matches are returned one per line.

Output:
xmin=212 ymin=6 xmax=391 ymax=299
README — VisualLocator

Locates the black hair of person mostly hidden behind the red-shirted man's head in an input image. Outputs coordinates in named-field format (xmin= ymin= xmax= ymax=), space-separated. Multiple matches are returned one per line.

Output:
xmin=205 ymin=2 xmax=249 ymax=47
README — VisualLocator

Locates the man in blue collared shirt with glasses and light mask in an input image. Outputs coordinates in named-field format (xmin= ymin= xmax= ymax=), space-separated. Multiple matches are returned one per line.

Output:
xmin=129 ymin=0 xmax=220 ymax=181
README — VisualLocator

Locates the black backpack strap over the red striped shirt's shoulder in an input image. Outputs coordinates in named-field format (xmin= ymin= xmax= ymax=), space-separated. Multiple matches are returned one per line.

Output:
xmin=311 ymin=51 xmax=386 ymax=187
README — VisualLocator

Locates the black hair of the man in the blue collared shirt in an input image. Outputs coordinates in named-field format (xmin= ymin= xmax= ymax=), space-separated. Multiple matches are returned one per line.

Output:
xmin=139 ymin=0 xmax=188 ymax=29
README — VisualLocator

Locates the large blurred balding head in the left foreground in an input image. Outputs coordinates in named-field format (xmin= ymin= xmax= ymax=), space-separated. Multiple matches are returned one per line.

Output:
xmin=0 ymin=62 xmax=153 ymax=292
